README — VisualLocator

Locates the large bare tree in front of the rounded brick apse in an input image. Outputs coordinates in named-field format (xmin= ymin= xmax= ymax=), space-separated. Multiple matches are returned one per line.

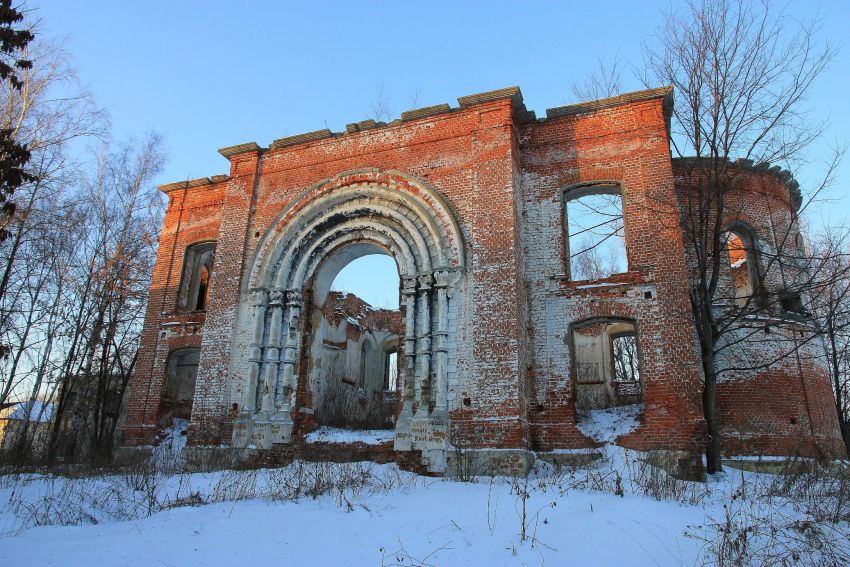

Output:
xmin=645 ymin=0 xmax=837 ymax=472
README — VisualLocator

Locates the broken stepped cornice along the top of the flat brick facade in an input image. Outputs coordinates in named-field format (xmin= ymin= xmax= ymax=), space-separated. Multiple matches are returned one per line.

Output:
xmin=159 ymin=86 xmax=673 ymax=193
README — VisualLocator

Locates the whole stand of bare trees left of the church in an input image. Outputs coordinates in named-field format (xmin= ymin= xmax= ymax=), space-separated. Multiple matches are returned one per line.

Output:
xmin=0 ymin=22 xmax=163 ymax=466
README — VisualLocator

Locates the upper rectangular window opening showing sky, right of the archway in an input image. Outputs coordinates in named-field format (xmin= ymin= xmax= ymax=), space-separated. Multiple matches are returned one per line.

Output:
xmin=564 ymin=183 xmax=628 ymax=280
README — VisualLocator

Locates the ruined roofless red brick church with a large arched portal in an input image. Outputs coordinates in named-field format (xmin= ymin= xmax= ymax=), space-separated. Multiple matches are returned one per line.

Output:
xmin=123 ymin=87 xmax=844 ymax=474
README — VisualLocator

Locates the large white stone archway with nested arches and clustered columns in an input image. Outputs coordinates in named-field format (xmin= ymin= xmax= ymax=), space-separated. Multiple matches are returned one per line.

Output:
xmin=232 ymin=169 xmax=464 ymax=466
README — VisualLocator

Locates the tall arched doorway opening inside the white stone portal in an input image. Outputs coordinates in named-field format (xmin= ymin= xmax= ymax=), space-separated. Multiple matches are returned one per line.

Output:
xmin=310 ymin=250 xmax=404 ymax=429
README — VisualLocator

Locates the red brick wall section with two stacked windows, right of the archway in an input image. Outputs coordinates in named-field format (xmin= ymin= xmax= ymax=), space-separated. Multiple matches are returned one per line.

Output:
xmin=521 ymin=98 xmax=701 ymax=450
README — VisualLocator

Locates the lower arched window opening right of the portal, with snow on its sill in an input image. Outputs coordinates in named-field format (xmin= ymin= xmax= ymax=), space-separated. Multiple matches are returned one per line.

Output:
xmin=570 ymin=318 xmax=643 ymax=414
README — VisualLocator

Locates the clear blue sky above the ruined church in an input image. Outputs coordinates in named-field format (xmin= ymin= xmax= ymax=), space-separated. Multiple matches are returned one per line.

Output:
xmin=27 ymin=0 xmax=850 ymax=306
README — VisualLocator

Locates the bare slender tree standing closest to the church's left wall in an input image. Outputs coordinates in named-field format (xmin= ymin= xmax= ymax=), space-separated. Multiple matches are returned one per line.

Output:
xmin=53 ymin=134 xmax=164 ymax=464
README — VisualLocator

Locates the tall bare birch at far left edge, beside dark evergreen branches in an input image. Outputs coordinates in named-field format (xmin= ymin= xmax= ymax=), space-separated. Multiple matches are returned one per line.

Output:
xmin=0 ymin=38 xmax=106 ymax=412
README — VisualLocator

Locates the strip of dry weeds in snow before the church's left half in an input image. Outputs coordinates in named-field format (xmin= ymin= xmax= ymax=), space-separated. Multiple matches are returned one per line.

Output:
xmin=0 ymin=459 xmax=416 ymax=536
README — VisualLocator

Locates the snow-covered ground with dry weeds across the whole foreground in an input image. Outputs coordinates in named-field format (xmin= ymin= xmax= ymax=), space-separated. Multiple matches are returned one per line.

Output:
xmin=0 ymin=418 xmax=850 ymax=566
